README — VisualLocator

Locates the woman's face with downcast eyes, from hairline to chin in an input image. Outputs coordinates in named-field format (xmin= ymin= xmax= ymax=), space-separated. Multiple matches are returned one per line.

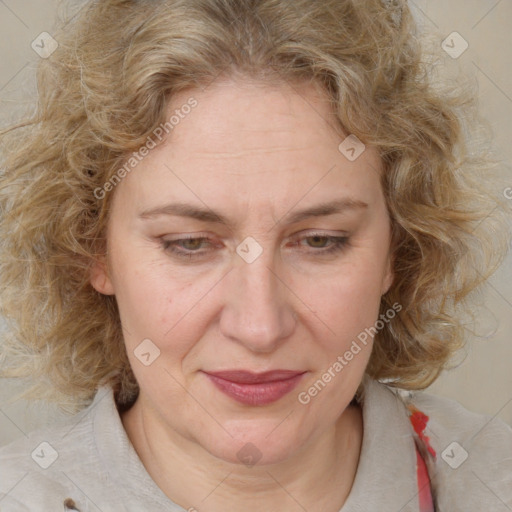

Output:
xmin=91 ymin=81 xmax=392 ymax=463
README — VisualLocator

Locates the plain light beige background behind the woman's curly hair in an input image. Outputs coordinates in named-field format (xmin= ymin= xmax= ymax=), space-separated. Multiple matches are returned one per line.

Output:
xmin=0 ymin=0 xmax=512 ymax=445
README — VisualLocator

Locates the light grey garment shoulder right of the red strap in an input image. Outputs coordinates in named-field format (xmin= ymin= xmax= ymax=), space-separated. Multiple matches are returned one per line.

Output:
xmin=390 ymin=384 xmax=512 ymax=510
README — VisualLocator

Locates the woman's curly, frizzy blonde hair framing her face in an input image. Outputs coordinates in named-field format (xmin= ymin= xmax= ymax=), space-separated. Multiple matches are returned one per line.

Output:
xmin=0 ymin=0 xmax=511 ymax=411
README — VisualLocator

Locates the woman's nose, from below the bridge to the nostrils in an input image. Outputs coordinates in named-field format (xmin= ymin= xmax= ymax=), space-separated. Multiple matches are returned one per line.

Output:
xmin=220 ymin=251 xmax=296 ymax=353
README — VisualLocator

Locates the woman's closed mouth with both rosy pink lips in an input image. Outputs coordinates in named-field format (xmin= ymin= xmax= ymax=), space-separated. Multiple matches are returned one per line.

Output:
xmin=204 ymin=370 xmax=307 ymax=406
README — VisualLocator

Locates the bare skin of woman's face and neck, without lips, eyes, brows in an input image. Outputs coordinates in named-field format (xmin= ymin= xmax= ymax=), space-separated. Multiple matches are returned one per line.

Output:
xmin=91 ymin=79 xmax=393 ymax=512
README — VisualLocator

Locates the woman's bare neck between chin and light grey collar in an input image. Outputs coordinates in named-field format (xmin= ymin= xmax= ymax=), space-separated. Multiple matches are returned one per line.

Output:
xmin=121 ymin=400 xmax=363 ymax=512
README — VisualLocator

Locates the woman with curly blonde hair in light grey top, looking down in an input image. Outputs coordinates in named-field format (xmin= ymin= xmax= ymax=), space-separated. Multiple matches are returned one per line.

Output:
xmin=0 ymin=0 xmax=512 ymax=512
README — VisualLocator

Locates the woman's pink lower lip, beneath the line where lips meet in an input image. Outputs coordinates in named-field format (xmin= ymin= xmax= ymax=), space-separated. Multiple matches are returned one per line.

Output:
xmin=207 ymin=373 xmax=304 ymax=405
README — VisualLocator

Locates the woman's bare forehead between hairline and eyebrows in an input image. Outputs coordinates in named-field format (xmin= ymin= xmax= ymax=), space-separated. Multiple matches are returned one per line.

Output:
xmin=113 ymin=76 xmax=380 ymax=212
